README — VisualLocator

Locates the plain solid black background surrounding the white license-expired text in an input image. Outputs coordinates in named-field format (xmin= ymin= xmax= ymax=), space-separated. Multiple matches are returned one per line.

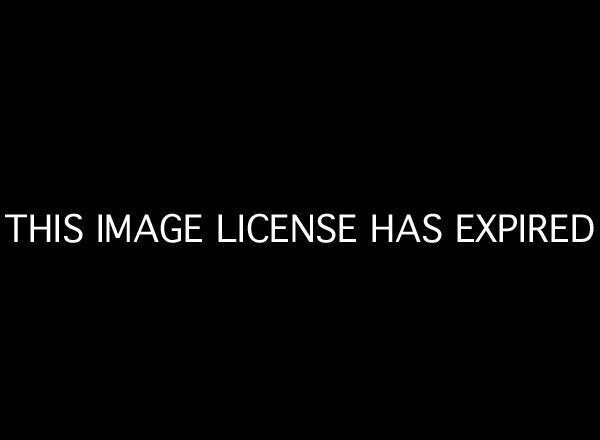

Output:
xmin=1 ymin=5 xmax=598 ymax=433
